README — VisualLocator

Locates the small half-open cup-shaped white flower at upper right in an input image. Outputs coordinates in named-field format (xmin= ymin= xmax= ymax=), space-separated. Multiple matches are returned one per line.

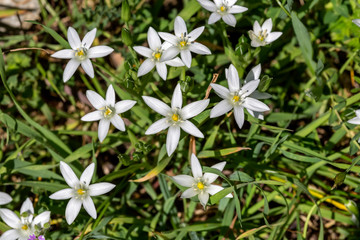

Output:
xmin=249 ymin=18 xmax=282 ymax=47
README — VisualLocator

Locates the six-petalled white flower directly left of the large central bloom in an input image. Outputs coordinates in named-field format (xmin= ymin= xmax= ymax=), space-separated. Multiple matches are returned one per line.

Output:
xmin=81 ymin=85 xmax=136 ymax=142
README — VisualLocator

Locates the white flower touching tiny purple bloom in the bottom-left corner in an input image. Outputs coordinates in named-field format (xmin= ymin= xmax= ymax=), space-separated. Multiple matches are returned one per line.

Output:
xmin=0 ymin=198 xmax=50 ymax=240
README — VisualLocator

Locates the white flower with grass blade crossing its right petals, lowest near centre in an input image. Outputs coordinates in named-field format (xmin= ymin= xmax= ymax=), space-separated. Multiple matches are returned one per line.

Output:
xmin=172 ymin=154 xmax=233 ymax=208
